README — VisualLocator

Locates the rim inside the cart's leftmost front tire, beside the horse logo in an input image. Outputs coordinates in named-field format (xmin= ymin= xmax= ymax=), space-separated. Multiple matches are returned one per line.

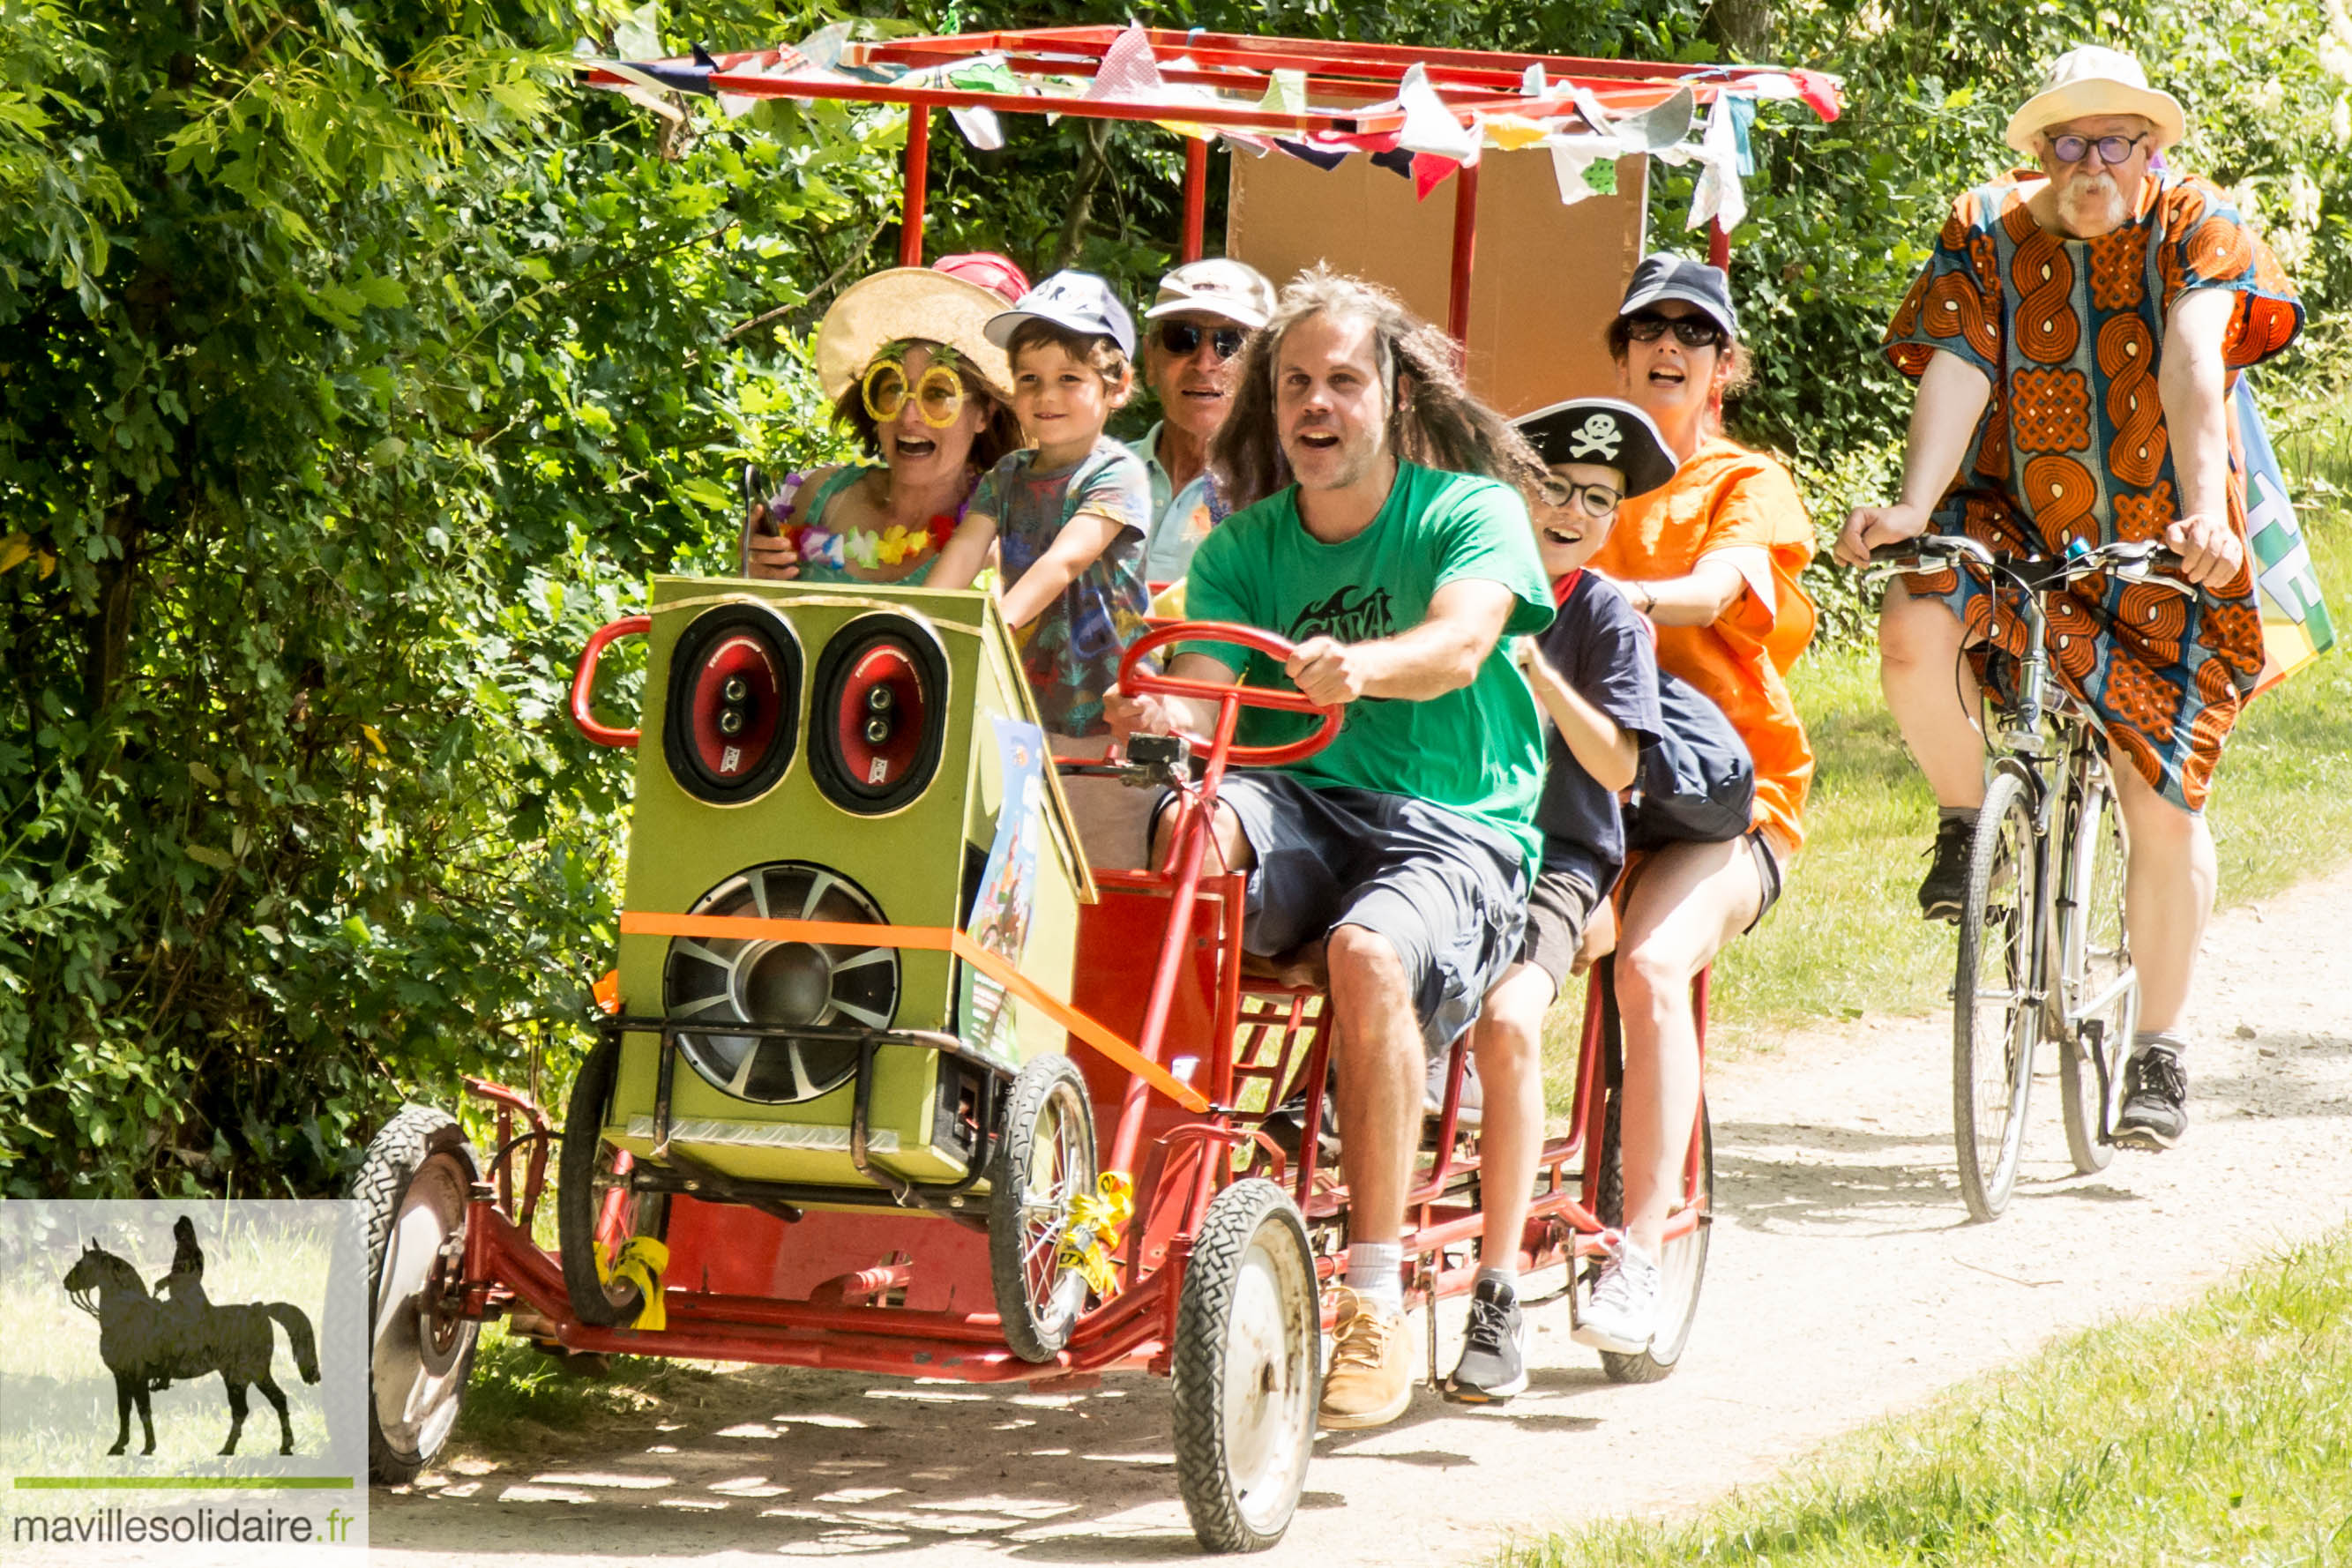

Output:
xmin=370 ymin=1154 xmax=477 ymax=1455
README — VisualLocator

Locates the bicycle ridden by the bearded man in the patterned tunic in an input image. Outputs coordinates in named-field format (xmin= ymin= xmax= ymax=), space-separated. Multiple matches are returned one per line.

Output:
xmin=1870 ymin=534 xmax=2194 ymax=1220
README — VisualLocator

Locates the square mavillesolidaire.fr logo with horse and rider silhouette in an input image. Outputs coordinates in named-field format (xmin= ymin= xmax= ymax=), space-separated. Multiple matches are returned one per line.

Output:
xmin=0 ymin=1198 xmax=374 ymax=1568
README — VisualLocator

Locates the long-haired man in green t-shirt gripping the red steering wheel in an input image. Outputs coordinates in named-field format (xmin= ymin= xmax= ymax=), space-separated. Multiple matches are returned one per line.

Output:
xmin=1105 ymin=271 xmax=1552 ymax=1427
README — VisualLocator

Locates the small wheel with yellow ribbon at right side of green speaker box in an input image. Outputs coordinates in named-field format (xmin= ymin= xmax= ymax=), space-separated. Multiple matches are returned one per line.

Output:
xmin=988 ymin=1051 xmax=1094 ymax=1361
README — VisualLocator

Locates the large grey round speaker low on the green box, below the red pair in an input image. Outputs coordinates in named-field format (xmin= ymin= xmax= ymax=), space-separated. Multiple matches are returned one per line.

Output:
xmin=661 ymin=861 xmax=899 ymax=1105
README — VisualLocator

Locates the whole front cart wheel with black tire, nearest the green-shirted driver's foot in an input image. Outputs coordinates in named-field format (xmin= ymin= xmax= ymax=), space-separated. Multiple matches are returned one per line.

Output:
xmin=1174 ymin=1177 xmax=1322 ymax=1551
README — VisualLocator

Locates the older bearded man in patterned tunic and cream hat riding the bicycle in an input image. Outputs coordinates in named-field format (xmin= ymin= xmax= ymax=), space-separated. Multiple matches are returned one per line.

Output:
xmin=1837 ymin=47 xmax=2303 ymax=1150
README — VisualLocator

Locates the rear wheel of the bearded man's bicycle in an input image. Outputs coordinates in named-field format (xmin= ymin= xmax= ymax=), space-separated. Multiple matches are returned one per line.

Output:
xmin=2058 ymin=757 xmax=2140 ymax=1176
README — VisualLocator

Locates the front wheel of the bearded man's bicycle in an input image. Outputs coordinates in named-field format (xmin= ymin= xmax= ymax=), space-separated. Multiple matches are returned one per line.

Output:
xmin=1953 ymin=773 xmax=2042 ymax=1220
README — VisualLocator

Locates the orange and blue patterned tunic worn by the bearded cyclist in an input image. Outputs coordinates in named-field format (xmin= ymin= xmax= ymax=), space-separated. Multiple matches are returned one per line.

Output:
xmin=1886 ymin=172 xmax=2303 ymax=811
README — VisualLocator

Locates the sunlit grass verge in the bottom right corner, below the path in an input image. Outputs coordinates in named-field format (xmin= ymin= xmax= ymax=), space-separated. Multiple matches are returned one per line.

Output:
xmin=1503 ymin=1232 xmax=2352 ymax=1568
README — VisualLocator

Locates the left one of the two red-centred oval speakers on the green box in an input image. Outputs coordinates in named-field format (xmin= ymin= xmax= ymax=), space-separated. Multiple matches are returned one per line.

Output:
xmin=661 ymin=604 xmax=802 ymax=806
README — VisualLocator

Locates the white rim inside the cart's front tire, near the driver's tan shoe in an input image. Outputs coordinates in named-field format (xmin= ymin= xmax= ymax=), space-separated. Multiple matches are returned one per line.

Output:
xmin=1221 ymin=1229 xmax=1315 ymax=1530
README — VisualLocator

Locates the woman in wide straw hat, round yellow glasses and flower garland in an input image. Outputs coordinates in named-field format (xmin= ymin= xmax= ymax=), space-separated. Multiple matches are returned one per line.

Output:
xmin=743 ymin=257 xmax=1023 ymax=583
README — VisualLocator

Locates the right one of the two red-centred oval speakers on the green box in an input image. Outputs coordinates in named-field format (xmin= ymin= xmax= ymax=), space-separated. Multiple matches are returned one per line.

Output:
xmin=809 ymin=614 xmax=948 ymax=816
